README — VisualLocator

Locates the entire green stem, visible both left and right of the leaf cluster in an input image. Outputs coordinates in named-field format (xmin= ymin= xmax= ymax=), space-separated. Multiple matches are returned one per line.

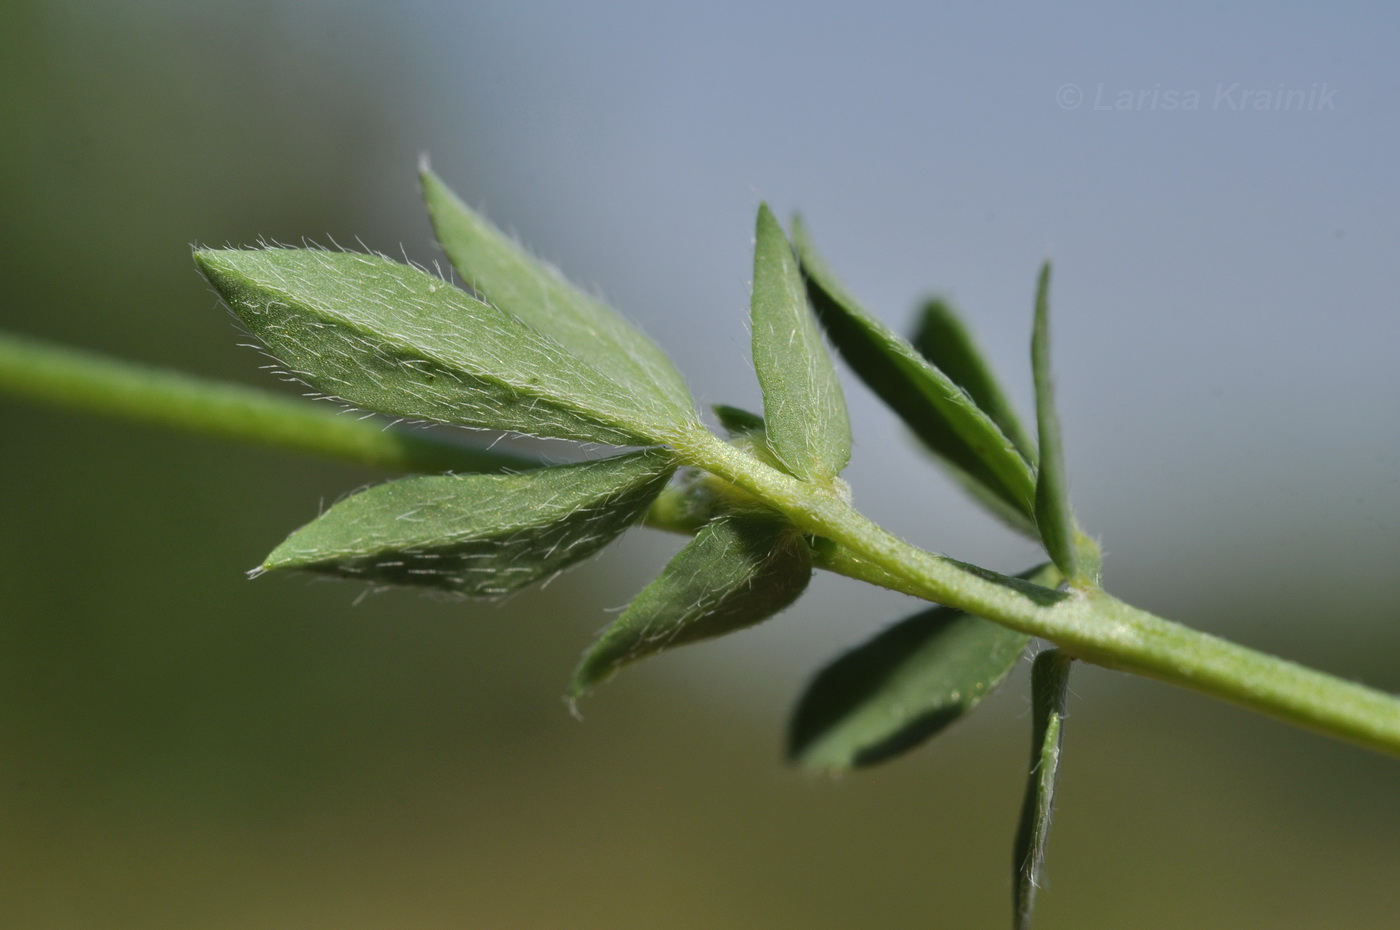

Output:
xmin=0 ymin=333 xmax=1400 ymax=755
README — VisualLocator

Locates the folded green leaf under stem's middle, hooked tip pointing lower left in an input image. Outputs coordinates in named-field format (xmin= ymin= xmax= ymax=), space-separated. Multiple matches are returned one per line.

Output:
xmin=573 ymin=513 xmax=812 ymax=698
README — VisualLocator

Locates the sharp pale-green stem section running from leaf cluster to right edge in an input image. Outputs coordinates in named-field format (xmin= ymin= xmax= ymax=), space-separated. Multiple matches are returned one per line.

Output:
xmin=673 ymin=430 xmax=1400 ymax=755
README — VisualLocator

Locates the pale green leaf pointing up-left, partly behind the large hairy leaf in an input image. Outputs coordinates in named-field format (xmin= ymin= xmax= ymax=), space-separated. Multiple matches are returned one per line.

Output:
xmin=420 ymin=165 xmax=694 ymax=417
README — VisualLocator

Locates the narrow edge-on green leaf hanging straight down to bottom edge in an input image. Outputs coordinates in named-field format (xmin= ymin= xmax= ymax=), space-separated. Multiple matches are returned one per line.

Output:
xmin=1012 ymin=648 xmax=1074 ymax=930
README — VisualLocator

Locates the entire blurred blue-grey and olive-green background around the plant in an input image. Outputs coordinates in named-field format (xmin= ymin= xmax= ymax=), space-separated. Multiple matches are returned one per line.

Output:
xmin=0 ymin=0 xmax=1400 ymax=930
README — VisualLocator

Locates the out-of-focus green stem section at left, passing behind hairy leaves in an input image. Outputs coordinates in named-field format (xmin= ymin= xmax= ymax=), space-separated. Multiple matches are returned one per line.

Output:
xmin=0 ymin=332 xmax=539 ymax=472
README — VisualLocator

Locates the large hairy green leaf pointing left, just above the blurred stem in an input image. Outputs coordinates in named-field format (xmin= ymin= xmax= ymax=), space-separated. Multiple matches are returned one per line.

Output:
xmin=195 ymin=248 xmax=693 ymax=445
